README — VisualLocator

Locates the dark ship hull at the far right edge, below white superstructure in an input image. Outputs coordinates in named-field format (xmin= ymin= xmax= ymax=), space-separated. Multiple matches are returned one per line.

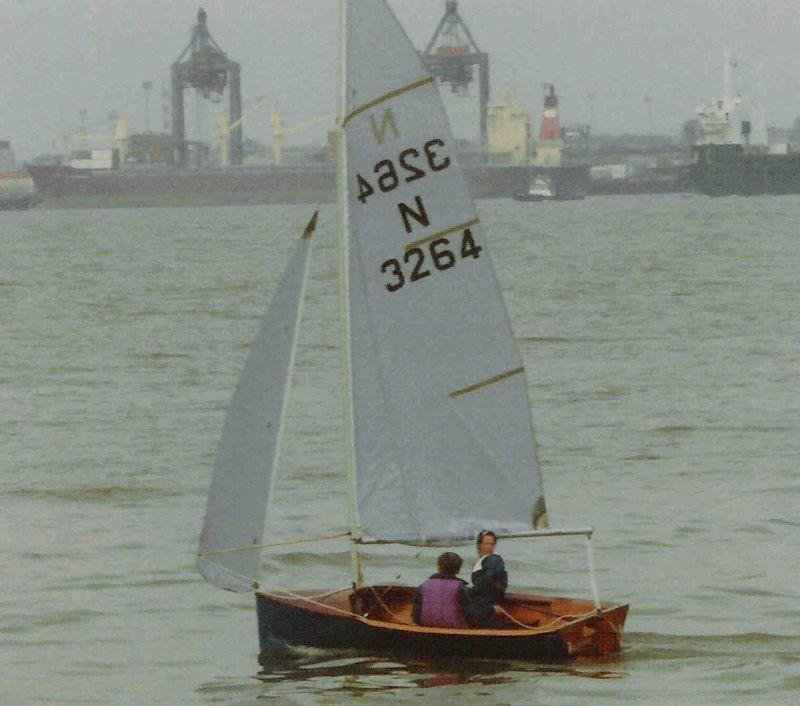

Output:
xmin=692 ymin=145 xmax=800 ymax=196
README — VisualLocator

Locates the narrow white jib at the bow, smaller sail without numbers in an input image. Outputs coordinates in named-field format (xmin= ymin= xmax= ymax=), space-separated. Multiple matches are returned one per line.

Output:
xmin=197 ymin=213 xmax=317 ymax=592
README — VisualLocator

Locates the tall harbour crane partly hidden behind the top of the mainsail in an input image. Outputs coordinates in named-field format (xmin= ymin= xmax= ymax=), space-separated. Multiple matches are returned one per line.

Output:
xmin=421 ymin=0 xmax=489 ymax=152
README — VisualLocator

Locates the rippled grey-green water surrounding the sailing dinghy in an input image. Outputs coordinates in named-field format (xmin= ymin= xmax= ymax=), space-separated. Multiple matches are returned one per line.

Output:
xmin=0 ymin=195 xmax=800 ymax=706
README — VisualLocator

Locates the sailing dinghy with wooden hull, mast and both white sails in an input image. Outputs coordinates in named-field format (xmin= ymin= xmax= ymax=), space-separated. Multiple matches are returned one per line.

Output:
xmin=198 ymin=0 xmax=628 ymax=660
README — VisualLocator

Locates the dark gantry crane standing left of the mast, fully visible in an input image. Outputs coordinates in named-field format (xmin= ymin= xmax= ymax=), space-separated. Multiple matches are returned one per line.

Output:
xmin=172 ymin=7 xmax=242 ymax=166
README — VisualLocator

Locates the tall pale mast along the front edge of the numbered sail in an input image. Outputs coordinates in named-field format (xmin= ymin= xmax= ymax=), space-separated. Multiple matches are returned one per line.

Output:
xmin=336 ymin=0 xmax=363 ymax=588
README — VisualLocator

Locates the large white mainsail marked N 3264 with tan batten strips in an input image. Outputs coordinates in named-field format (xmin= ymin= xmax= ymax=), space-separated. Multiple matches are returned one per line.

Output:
xmin=344 ymin=0 xmax=547 ymax=543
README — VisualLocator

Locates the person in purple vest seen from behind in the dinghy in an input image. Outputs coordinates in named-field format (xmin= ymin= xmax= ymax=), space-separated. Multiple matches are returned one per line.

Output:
xmin=411 ymin=552 xmax=472 ymax=628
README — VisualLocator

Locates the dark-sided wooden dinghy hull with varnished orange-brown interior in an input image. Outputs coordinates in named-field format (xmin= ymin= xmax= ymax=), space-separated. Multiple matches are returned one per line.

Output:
xmin=256 ymin=586 xmax=628 ymax=663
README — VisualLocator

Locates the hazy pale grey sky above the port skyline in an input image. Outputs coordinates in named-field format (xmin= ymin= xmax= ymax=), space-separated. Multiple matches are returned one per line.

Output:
xmin=0 ymin=0 xmax=800 ymax=159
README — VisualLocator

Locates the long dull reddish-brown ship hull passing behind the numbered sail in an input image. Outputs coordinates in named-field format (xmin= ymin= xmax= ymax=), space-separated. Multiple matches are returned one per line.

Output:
xmin=28 ymin=165 xmax=589 ymax=208
